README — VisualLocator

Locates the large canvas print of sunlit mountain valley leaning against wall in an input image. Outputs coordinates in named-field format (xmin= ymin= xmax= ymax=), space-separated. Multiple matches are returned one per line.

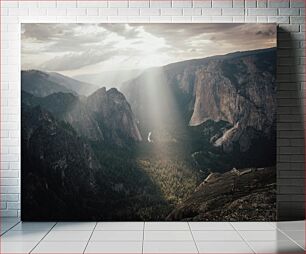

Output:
xmin=21 ymin=23 xmax=276 ymax=221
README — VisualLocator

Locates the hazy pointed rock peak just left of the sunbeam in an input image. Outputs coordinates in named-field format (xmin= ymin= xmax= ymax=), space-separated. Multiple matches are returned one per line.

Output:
xmin=87 ymin=88 xmax=142 ymax=145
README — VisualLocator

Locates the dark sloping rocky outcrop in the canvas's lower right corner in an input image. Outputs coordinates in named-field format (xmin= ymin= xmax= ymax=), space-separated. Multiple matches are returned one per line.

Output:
xmin=167 ymin=168 xmax=276 ymax=221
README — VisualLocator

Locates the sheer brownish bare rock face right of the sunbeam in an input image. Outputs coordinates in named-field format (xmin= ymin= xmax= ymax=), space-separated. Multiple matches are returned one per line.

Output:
xmin=189 ymin=55 xmax=276 ymax=151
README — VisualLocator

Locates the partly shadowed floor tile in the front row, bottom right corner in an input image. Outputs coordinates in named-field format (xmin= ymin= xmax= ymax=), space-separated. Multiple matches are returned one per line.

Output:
xmin=248 ymin=241 xmax=304 ymax=254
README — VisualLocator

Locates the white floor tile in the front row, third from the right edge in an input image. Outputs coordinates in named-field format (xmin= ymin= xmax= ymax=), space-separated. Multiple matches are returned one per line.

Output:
xmin=143 ymin=242 xmax=198 ymax=254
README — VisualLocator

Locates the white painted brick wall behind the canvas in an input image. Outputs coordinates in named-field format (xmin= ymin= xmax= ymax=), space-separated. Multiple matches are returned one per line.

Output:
xmin=0 ymin=0 xmax=305 ymax=218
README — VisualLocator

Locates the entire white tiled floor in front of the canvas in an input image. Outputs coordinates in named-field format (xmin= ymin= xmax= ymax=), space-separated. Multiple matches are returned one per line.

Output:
xmin=0 ymin=219 xmax=305 ymax=254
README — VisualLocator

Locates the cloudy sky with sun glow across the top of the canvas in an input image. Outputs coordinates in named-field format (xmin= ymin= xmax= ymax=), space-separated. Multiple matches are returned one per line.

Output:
xmin=21 ymin=24 xmax=276 ymax=76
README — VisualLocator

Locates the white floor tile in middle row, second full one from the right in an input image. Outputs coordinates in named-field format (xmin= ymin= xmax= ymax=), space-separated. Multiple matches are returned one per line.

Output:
xmin=192 ymin=231 xmax=243 ymax=242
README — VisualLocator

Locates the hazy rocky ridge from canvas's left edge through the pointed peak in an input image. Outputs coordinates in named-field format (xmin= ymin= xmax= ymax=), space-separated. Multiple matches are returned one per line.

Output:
xmin=22 ymin=88 xmax=141 ymax=146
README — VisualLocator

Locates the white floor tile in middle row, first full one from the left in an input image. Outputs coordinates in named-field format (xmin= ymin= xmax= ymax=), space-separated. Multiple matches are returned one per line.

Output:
xmin=42 ymin=230 xmax=92 ymax=242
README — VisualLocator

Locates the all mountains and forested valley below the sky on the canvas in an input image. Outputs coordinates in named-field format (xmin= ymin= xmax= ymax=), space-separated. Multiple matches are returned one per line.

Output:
xmin=21 ymin=48 xmax=276 ymax=220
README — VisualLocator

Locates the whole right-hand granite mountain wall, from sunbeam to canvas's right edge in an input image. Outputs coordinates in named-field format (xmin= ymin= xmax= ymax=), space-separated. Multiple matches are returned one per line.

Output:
xmin=123 ymin=48 xmax=276 ymax=152
